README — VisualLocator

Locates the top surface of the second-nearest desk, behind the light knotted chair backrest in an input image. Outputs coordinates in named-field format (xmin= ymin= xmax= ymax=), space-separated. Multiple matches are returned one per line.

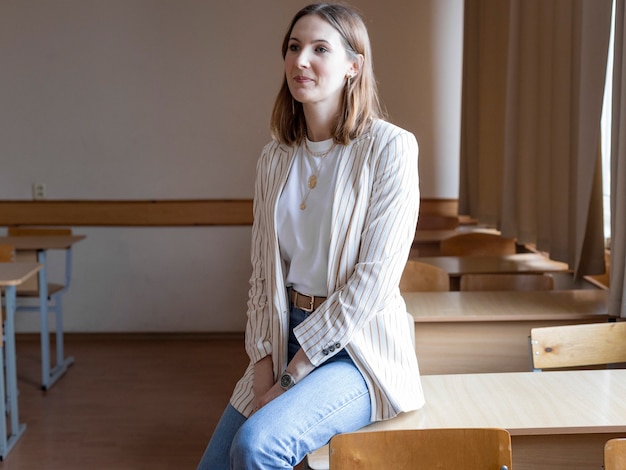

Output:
xmin=402 ymin=289 xmax=609 ymax=323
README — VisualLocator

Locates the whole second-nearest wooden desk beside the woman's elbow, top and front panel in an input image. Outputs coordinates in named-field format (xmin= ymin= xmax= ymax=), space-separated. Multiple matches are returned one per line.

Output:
xmin=402 ymin=289 xmax=609 ymax=374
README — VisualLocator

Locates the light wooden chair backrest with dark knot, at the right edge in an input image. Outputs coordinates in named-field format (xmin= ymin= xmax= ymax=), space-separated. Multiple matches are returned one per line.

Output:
xmin=530 ymin=322 xmax=626 ymax=371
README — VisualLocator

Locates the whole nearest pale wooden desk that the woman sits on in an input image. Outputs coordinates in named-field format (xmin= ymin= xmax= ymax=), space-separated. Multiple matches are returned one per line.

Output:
xmin=308 ymin=369 xmax=626 ymax=470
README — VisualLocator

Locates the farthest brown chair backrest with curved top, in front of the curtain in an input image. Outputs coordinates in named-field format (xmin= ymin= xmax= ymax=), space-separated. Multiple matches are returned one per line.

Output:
xmin=440 ymin=232 xmax=517 ymax=256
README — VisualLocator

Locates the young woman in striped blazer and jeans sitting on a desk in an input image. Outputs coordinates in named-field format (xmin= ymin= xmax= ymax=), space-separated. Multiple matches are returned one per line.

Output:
xmin=198 ymin=4 xmax=424 ymax=470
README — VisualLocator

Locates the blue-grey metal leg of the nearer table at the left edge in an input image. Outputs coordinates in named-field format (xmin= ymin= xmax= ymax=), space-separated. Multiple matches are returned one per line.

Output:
xmin=0 ymin=286 xmax=26 ymax=459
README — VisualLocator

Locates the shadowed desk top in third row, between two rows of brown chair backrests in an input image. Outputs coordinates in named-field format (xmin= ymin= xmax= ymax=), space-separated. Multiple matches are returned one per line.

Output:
xmin=419 ymin=253 xmax=569 ymax=277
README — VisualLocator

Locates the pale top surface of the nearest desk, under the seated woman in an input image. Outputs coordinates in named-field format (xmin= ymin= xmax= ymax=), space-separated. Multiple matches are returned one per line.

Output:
xmin=365 ymin=369 xmax=626 ymax=436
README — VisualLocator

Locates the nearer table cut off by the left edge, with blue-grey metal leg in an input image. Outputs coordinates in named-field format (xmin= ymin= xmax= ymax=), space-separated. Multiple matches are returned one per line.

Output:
xmin=0 ymin=263 xmax=41 ymax=460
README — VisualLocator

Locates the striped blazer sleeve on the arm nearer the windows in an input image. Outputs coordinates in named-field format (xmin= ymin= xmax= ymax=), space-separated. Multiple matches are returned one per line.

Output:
xmin=294 ymin=127 xmax=419 ymax=365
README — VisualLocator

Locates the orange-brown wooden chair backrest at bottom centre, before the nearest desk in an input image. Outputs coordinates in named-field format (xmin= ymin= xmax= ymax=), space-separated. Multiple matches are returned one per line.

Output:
xmin=330 ymin=428 xmax=512 ymax=470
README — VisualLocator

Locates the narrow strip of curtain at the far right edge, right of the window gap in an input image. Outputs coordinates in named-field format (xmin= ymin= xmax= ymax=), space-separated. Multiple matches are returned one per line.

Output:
xmin=609 ymin=0 xmax=626 ymax=318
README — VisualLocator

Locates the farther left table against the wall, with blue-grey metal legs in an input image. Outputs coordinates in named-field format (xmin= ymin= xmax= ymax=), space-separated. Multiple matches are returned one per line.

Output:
xmin=0 ymin=235 xmax=85 ymax=390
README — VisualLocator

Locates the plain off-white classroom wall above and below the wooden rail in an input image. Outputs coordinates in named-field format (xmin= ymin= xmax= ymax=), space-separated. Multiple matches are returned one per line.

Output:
xmin=0 ymin=0 xmax=463 ymax=332
